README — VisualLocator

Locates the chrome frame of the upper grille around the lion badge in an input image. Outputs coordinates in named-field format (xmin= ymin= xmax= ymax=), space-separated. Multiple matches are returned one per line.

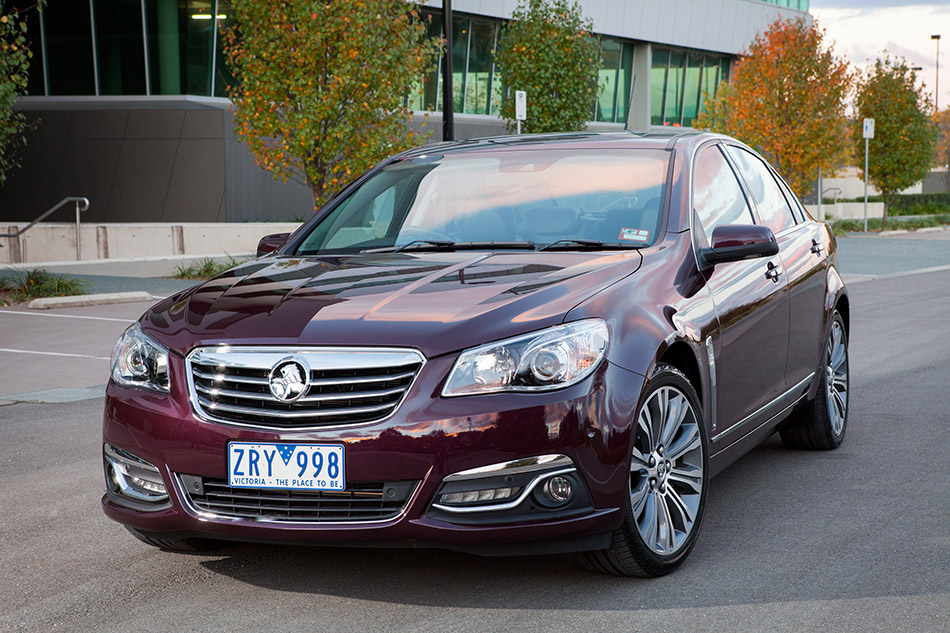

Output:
xmin=185 ymin=344 xmax=427 ymax=432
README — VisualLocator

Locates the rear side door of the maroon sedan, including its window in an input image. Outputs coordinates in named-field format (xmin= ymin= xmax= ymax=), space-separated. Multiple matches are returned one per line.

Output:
xmin=727 ymin=145 xmax=827 ymax=388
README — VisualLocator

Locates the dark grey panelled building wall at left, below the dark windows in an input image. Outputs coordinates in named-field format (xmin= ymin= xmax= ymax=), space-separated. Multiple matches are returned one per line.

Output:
xmin=0 ymin=97 xmax=313 ymax=222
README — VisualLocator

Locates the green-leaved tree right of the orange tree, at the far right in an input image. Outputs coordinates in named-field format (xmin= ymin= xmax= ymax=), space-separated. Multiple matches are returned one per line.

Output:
xmin=854 ymin=57 xmax=937 ymax=225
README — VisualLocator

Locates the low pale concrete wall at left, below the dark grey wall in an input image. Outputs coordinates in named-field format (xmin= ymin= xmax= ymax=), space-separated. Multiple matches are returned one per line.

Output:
xmin=0 ymin=222 xmax=300 ymax=264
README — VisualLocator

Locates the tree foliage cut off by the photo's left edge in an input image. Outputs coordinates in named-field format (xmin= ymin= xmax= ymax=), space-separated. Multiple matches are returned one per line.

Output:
xmin=0 ymin=2 xmax=33 ymax=185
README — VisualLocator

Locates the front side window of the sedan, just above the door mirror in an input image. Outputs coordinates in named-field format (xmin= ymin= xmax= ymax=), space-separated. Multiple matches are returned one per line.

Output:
xmin=693 ymin=145 xmax=755 ymax=243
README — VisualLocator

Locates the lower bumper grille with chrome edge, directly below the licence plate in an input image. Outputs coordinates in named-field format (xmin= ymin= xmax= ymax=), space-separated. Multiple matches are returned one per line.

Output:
xmin=179 ymin=475 xmax=419 ymax=523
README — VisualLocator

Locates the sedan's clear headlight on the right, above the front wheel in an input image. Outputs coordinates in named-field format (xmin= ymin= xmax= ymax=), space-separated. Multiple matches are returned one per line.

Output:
xmin=442 ymin=319 xmax=607 ymax=397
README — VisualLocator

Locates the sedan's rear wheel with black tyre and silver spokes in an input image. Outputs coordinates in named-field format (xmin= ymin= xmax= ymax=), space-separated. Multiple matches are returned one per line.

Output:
xmin=779 ymin=311 xmax=850 ymax=451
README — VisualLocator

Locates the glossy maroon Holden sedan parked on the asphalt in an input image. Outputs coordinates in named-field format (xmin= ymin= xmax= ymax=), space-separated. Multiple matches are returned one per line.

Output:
xmin=102 ymin=132 xmax=849 ymax=576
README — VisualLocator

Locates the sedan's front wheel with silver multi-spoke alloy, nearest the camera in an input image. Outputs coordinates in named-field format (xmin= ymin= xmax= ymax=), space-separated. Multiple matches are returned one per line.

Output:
xmin=583 ymin=364 xmax=709 ymax=577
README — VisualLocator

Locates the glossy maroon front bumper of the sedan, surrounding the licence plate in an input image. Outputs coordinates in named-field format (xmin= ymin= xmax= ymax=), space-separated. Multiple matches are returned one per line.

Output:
xmin=102 ymin=358 xmax=643 ymax=554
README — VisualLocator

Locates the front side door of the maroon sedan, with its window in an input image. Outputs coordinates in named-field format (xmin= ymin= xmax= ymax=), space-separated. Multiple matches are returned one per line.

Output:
xmin=692 ymin=143 xmax=789 ymax=441
